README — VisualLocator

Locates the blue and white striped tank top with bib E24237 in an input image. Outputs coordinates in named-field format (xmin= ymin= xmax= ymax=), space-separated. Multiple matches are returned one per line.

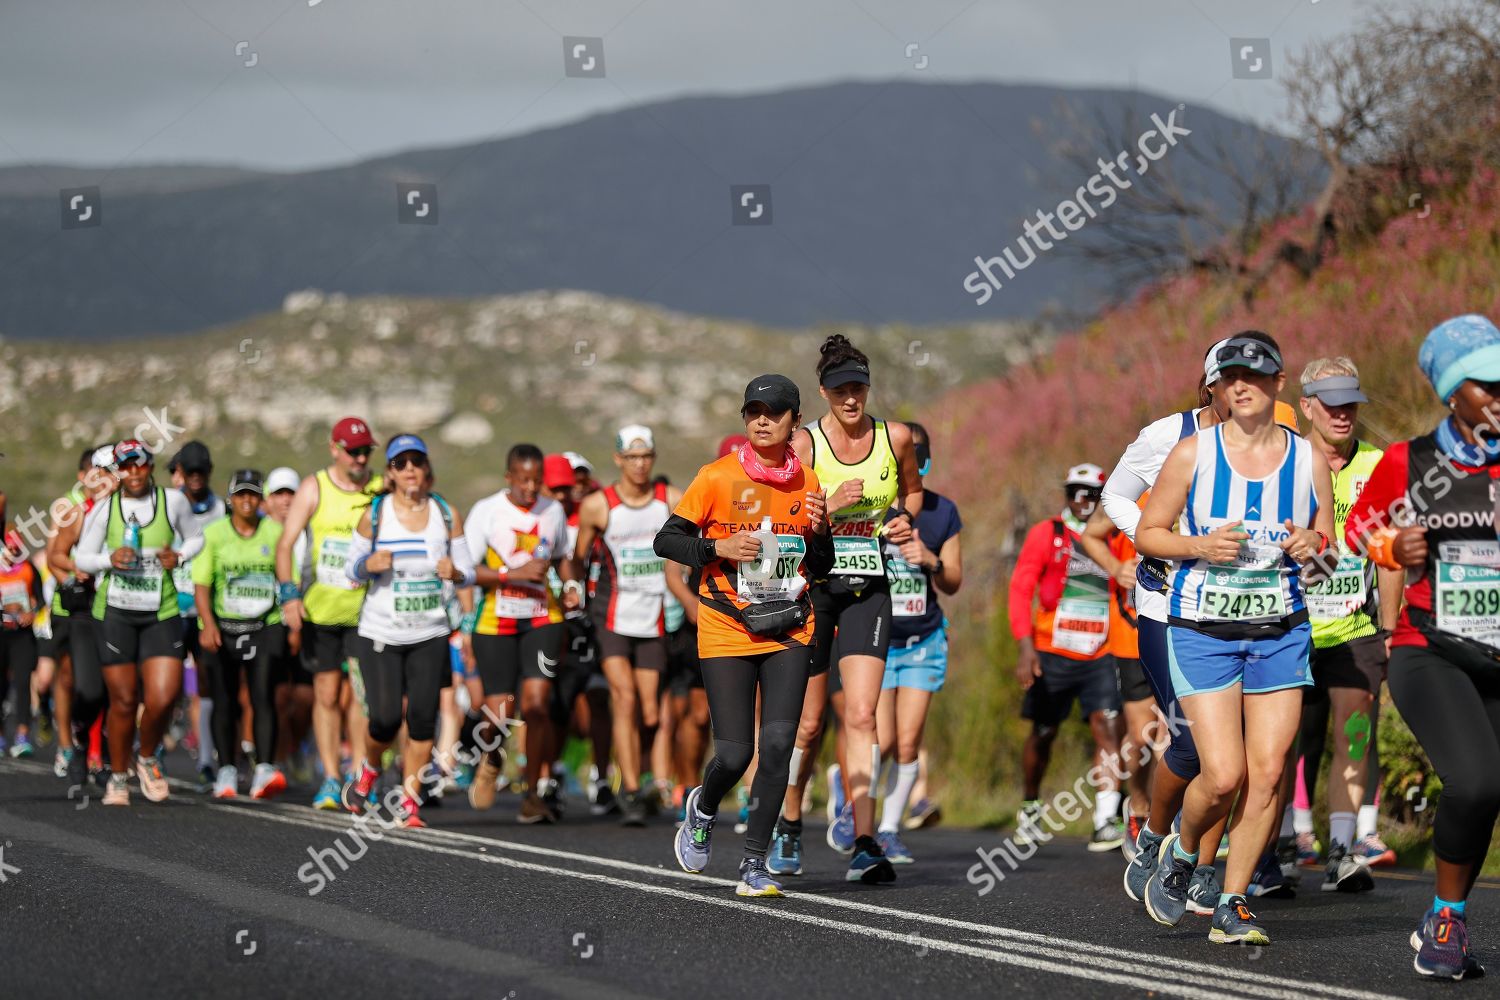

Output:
xmin=1172 ymin=424 xmax=1317 ymax=625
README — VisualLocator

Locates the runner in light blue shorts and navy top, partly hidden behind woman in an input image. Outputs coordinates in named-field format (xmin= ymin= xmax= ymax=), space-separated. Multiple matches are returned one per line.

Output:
xmin=864 ymin=424 xmax=963 ymax=870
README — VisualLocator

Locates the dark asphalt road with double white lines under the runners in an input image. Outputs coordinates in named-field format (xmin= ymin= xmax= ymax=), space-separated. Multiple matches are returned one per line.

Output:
xmin=0 ymin=762 xmax=1476 ymax=1000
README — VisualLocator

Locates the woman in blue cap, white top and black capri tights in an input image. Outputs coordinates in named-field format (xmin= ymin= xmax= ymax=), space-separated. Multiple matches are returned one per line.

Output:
xmin=345 ymin=435 xmax=474 ymax=826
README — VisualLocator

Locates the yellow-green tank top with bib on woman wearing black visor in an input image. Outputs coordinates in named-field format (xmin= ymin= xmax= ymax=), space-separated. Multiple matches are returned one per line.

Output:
xmin=807 ymin=420 xmax=902 ymax=577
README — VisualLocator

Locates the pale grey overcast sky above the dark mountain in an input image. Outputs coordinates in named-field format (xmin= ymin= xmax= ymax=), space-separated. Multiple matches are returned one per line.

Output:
xmin=0 ymin=0 xmax=1446 ymax=169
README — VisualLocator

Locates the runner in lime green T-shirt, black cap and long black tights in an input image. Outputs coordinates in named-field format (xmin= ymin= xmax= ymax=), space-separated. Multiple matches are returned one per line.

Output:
xmin=192 ymin=469 xmax=287 ymax=799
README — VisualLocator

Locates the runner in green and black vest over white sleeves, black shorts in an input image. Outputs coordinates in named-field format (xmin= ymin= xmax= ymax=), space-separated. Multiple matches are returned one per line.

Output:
xmin=74 ymin=439 xmax=203 ymax=805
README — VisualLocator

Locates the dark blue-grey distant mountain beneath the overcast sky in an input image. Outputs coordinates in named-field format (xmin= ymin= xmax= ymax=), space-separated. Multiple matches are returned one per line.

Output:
xmin=0 ymin=82 xmax=1286 ymax=340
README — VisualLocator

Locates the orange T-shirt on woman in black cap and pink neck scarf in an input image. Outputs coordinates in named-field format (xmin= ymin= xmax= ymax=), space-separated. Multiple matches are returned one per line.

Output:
xmin=672 ymin=453 xmax=819 ymax=660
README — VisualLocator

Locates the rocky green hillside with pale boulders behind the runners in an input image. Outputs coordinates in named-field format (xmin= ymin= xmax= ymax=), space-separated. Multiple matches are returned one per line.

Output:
xmin=0 ymin=291 xmax=1050 ymax=520
